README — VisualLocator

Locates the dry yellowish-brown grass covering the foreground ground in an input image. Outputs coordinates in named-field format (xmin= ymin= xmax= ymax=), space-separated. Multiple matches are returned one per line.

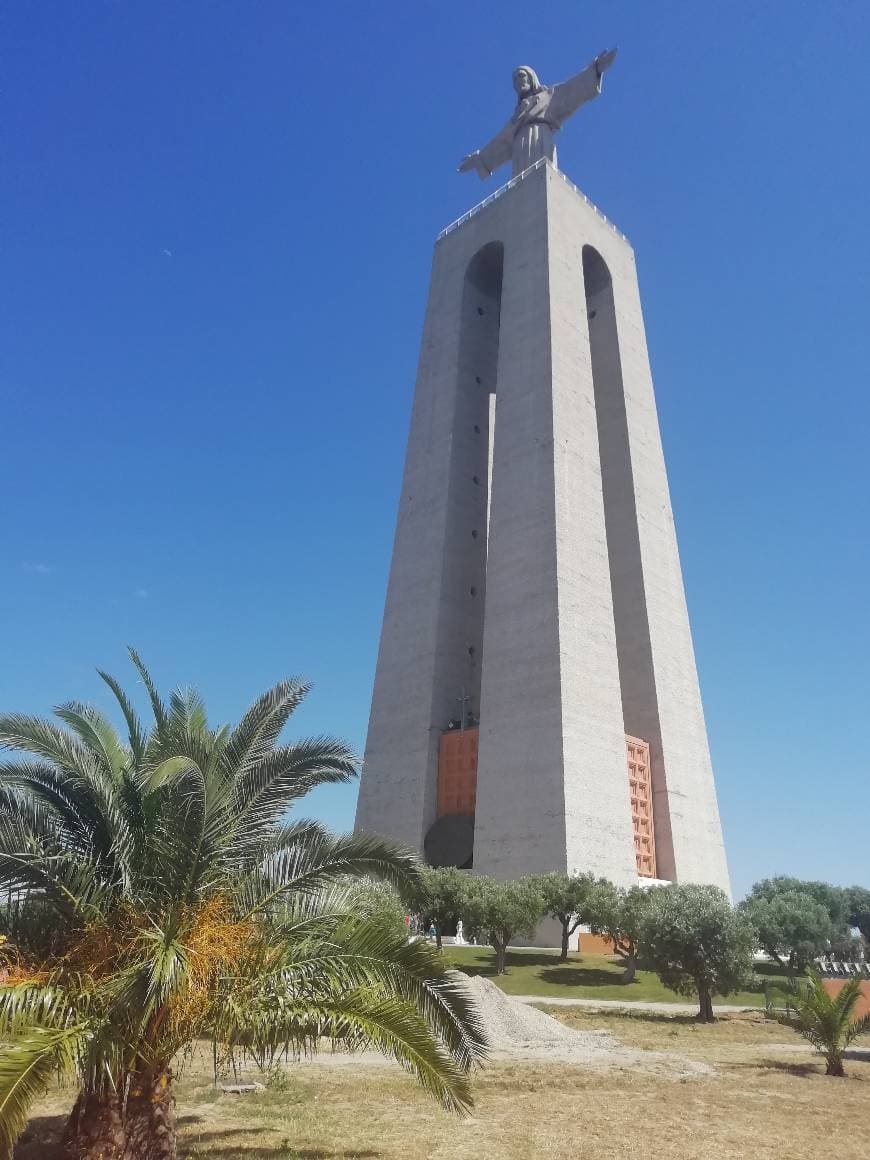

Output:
xmin=16 ymin=1008 xmax=870 ymax=1160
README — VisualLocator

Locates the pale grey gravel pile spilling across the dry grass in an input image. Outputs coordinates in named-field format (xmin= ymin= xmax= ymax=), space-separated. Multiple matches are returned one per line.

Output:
xmin=467 ymin=976 xmax=712 ymax=1079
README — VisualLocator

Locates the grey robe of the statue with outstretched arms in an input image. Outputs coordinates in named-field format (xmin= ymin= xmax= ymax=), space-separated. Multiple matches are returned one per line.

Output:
xmin=474 ymin=61 xmax=601 ymax=177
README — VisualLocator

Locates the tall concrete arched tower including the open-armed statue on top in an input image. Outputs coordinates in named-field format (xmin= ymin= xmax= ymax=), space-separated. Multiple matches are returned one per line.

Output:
xmin=356 ymin=52 xmax=728 ymax=891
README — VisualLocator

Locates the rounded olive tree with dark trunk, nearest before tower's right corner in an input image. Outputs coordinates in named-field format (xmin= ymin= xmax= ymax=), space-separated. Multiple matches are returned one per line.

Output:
xmin=639 ymin=884 xmax=754 ymax=1023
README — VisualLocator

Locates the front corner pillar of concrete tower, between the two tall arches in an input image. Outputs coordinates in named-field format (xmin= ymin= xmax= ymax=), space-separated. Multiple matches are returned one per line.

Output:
xmin=474 ymin=167 xmax=636 ymax=885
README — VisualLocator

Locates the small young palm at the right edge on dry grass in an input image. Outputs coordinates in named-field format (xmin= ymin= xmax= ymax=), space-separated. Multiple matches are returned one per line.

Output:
xmin=766 ymin=967 xmax=870 ymax=1075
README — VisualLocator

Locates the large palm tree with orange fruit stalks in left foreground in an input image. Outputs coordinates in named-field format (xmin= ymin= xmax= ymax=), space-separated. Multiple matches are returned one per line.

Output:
xmin=0 ymin=650 xmax=485 ymax=1160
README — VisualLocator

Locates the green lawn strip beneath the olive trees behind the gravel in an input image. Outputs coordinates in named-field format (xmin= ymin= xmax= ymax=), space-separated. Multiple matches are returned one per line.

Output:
xmin=444 ymin=947 xmax=782 ymax=1007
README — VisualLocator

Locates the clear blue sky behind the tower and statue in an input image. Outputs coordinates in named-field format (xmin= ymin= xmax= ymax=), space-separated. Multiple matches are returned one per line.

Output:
xmin=0 ymin=0 xmax=870 ymax=894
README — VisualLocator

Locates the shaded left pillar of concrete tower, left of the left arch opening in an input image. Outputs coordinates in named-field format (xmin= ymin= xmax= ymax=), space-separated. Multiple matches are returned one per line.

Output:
xmin=356 ymin=219 xmax=502 ymax=851
